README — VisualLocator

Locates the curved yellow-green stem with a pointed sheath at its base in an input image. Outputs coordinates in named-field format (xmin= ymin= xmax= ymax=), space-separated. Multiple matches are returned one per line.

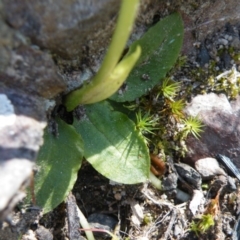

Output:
xmin=64 ymin=0 xmax=141 ymax=111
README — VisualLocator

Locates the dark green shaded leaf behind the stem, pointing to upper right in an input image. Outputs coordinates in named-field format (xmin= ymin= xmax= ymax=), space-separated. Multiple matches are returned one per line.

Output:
xmin=110 ymin=13 xmax=183 ymax=102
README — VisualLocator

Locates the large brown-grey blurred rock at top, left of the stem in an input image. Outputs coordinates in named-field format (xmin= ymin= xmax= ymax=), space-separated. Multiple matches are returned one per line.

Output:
xmin=3 ymin=0 xmax=120 ymax=60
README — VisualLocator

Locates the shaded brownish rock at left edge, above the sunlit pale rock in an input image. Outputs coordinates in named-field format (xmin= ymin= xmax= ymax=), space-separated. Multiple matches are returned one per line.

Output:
xmin=0 ymin=18 xmax=66 ymax=98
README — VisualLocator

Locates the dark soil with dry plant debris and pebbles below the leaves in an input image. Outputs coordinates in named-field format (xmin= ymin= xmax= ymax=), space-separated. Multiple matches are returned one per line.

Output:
xmin=0 ymin=159 xmax=240 ymax=240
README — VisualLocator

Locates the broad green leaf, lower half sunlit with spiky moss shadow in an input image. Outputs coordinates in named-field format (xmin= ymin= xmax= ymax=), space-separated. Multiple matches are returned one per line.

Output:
xmin=73 ymin=102 xmax=150 ymax=184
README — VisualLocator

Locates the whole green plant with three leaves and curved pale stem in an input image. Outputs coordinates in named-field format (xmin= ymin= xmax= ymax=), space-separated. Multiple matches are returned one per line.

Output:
xmin=31 ymin=0 xmax=183 ymax=213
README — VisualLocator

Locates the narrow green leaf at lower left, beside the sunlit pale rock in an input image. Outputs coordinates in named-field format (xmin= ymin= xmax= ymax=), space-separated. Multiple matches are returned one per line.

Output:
xmin=35 ymin=120 xmax=83 ymax=213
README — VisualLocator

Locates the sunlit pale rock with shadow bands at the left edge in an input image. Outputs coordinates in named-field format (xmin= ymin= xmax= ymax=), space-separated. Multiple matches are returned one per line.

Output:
xmin=0 ymin=86 xmax=46 ymax=220
